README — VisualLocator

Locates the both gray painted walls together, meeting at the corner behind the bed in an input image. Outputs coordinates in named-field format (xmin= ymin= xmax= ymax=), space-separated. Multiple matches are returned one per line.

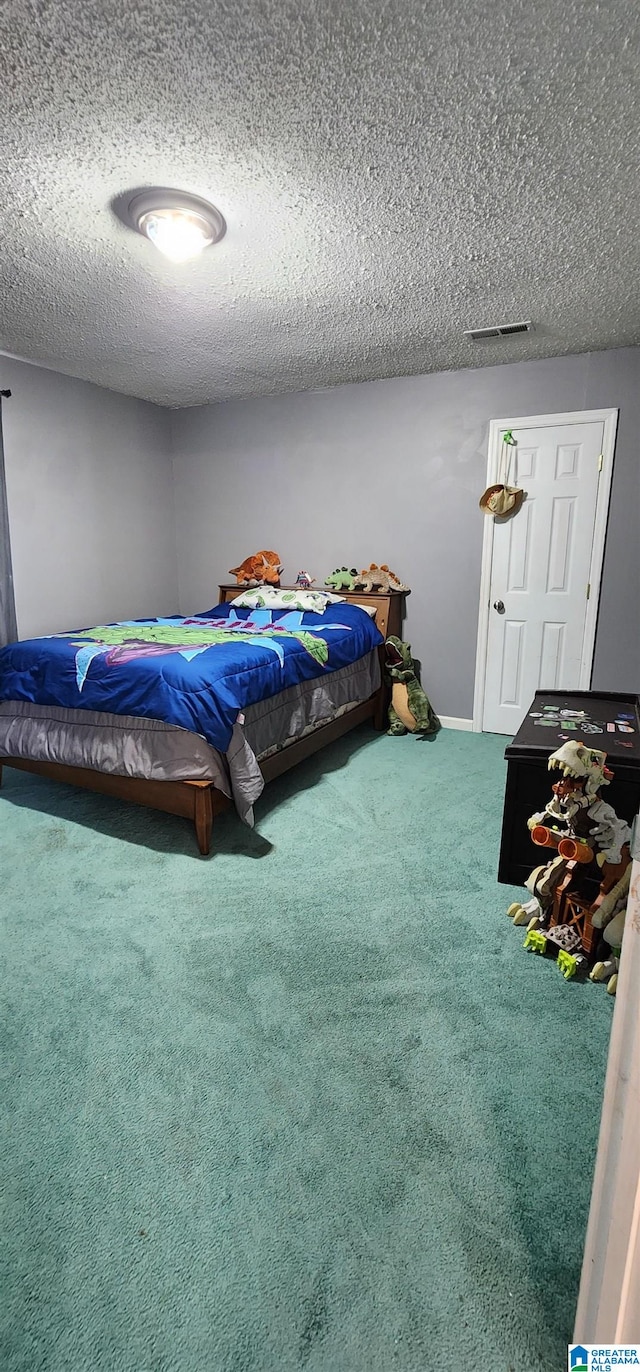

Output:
xmin=0 ymin=348 xmax=640 ymax=718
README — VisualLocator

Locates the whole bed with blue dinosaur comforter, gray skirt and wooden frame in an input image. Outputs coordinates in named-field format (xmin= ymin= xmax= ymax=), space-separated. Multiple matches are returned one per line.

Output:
xmin=0 ymin=586 xmax=404 ymax=856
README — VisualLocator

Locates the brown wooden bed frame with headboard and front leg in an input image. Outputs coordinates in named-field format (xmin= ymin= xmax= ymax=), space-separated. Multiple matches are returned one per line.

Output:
xmin=0 ymin=586 xmax=404 ymax=858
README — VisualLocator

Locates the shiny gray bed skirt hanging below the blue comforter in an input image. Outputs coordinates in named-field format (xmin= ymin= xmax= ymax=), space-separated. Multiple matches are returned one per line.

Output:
xmin=0 ymin=649 xmax=380 ymax=823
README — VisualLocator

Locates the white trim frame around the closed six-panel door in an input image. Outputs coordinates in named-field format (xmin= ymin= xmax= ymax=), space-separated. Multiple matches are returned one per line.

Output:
xmin=472 ymin=409 xmax=618 ymax=734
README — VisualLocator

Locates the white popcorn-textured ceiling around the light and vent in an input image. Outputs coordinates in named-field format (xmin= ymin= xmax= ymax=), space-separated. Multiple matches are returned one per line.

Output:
xmin=0 ymin=0 xmax=640 ymax=405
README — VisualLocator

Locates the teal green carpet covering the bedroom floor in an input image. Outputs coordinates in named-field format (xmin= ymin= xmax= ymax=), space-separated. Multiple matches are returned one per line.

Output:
xmin=0 ymin=727 xmax=611 ymax=1372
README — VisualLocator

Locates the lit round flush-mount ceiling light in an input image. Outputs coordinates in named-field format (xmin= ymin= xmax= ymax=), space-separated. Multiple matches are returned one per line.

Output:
xmin=128 ymin=188 xmax=227 ymax=262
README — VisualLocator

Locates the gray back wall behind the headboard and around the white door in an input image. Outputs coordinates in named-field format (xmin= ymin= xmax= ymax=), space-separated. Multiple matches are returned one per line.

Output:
xmin=172 ymin=348 xmax=640 ymax=718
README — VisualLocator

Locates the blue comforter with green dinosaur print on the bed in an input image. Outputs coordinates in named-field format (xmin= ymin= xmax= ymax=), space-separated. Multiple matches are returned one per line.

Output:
xmin=0 ymin=602 xmax=382 ymax=752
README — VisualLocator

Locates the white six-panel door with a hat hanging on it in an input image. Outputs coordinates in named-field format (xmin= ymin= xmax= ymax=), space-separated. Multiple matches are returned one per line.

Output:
xmin=482 ymin=412 xmax=615 ymax=734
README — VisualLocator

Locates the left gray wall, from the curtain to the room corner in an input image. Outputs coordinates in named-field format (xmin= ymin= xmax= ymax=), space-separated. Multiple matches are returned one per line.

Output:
xmin=0 ymin=355 xmax=177 ymax=638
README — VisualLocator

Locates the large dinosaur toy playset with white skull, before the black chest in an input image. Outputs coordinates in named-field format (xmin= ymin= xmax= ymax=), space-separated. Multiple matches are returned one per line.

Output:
xmin=507 ymin=740 xmax=630 ymax=989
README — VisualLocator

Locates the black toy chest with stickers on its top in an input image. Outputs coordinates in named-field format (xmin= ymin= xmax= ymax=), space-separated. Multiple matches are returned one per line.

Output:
xmin=497 ymin=690 xmax=640 ymax=886
